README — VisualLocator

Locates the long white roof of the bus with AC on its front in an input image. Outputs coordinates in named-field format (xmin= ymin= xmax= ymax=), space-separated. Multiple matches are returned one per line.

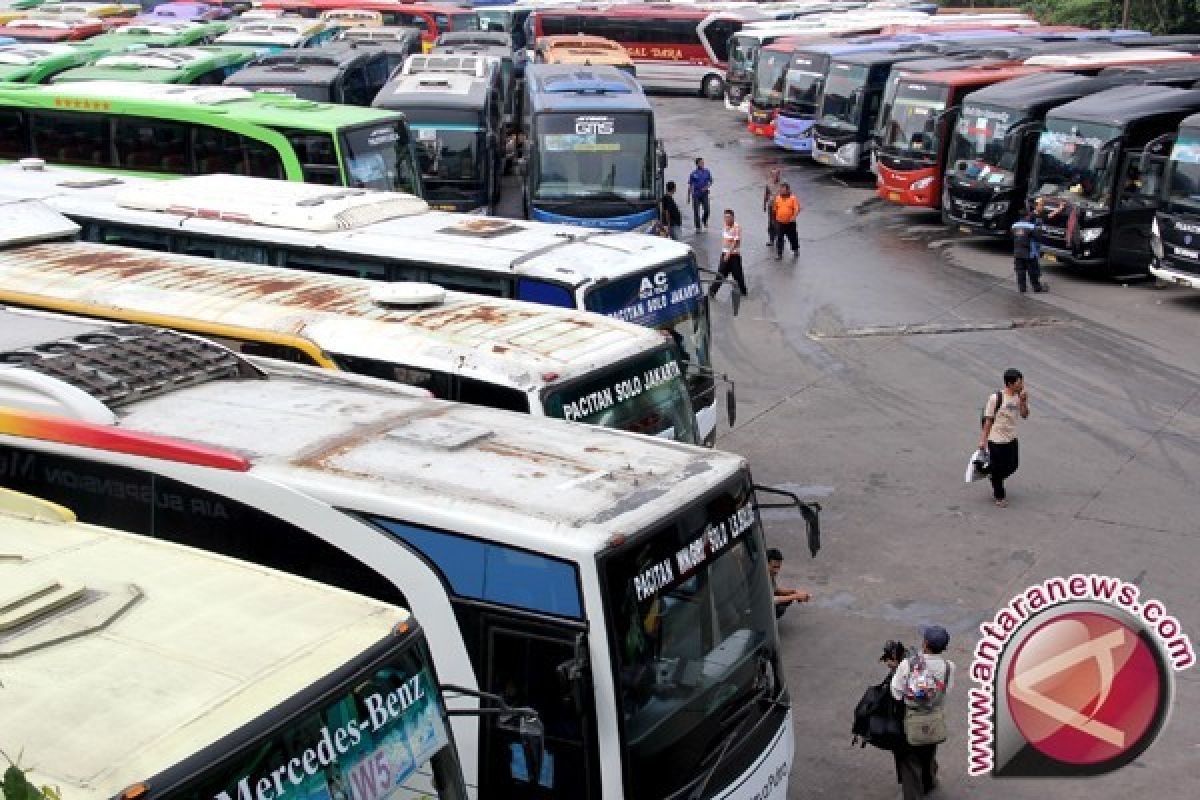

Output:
xmin=0 ymin=164 xmax=691 ymax=298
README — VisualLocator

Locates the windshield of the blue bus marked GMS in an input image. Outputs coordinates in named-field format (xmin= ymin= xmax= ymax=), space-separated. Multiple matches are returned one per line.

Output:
xmin=533 ymin=112 xmax=654 ymax=201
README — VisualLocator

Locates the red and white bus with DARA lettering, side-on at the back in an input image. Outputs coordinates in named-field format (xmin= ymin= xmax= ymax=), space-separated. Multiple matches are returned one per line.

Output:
xmin=526 ymin=4 xmax=768 ymax=100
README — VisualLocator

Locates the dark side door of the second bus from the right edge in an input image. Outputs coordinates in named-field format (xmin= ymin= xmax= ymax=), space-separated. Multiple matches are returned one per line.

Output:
xmin=1108 ymin=142 xmax=1171 ymax=270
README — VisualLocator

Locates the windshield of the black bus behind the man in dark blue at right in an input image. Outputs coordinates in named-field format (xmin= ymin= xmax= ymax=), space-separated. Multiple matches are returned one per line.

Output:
xmin=1033 ymin=120 xmax=1121 ymax=206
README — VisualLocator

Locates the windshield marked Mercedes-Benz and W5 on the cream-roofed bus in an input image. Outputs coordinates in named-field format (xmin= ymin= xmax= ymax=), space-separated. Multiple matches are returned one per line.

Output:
xmin=175 ymin=636 xmax=466 ymax=800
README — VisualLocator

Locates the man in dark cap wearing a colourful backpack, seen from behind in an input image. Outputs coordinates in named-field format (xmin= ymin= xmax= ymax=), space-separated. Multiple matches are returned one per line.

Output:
xmin=892 ymin=625 xmax=954 ymax=800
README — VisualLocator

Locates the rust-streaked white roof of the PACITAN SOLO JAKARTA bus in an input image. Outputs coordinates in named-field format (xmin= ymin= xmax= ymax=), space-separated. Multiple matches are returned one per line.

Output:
xmin=0 ymin=237 xmax=664 ymax=392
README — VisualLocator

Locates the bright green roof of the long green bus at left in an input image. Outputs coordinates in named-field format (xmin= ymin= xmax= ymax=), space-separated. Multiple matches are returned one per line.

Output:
xmin=0 ymin=80 xmax=400 ymax=132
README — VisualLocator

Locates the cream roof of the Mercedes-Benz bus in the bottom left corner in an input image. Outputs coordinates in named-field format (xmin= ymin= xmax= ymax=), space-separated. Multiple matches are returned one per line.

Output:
xmin=0 ymin=489 xmax=412 ymax=800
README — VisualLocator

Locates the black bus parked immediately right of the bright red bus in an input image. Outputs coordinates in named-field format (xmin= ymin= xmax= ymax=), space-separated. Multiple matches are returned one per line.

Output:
xmin=942 ymin=64 xmax=1200 ymax=236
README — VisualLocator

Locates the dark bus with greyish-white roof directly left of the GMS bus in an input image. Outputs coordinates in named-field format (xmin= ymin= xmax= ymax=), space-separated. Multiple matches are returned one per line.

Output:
xmin=374 ymin=72 xmax=508 ymax=215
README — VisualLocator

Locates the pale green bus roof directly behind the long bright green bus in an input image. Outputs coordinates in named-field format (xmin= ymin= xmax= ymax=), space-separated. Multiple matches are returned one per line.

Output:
xmin=50 ymin=47 xmax=258 ymax=86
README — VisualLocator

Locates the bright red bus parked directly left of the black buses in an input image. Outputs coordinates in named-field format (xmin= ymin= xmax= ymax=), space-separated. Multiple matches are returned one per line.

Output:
xmin=875 ymin=50 xmax=1188 ymax=209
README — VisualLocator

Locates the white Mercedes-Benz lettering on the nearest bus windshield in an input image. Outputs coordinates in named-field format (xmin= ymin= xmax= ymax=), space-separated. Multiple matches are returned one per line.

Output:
xmin=212 ymin=674 xmax=425 ymax=800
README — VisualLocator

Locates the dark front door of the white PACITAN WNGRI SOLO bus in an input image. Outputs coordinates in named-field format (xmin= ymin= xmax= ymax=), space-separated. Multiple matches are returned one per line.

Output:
xmin=478 ymin=612 xmax=595 ymax=800
